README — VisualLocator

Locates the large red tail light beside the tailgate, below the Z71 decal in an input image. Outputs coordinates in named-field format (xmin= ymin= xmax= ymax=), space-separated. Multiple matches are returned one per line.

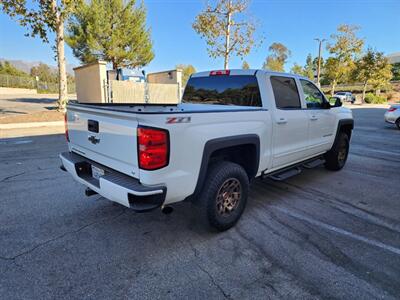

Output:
xmin=137 ymin=127 xmax=169 ymax=170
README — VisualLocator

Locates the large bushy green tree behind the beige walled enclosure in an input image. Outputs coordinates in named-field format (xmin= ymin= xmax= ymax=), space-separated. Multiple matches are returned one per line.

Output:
xmin=66 ymin=0 xmax=154 ymax=69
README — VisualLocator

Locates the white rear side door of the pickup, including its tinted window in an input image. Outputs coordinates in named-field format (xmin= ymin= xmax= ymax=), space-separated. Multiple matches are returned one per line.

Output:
xmin=270 ymin=76 xmax=308 ymax=168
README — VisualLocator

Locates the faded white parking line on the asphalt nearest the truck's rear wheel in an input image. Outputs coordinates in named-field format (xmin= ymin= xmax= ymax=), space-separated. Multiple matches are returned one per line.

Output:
xmin=273 ymin=206 xmax=400 ymax=255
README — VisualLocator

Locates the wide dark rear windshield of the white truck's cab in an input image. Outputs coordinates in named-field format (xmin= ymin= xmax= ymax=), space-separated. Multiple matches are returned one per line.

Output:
xmin=182 ymin=75 xmax=262 ymax=106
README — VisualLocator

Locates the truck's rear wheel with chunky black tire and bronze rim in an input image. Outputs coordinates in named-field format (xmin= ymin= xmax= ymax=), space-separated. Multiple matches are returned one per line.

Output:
xmin=197 ymin=161 xmax=249 ymax=231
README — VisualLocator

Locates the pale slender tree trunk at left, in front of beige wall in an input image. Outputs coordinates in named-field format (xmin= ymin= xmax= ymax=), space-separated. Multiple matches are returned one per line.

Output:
xmin=52 ymin=0 xmax=68 ymax=111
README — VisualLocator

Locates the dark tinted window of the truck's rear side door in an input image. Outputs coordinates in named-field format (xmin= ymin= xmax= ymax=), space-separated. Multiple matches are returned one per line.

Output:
xmin=271 ymin=76 xmax=301 ymax=109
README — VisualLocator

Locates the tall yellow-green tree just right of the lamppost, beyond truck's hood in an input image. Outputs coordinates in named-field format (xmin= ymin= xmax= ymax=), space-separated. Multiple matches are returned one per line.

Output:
xmin=327 ymin=25 xmax=364 ymax=95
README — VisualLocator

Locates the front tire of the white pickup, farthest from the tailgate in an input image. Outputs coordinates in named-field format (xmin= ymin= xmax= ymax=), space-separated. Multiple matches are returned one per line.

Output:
xmin=325 ymin=132 xmax=349 ymax=171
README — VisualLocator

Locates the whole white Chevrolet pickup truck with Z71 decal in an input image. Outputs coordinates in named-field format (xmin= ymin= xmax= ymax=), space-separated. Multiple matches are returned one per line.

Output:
xmin=60 ymin=70 xmax=353 ymax=231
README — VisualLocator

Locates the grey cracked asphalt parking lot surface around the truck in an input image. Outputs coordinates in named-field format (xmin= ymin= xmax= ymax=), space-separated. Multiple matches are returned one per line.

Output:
xmin=0 ymin=108 xmax=400 ymax=299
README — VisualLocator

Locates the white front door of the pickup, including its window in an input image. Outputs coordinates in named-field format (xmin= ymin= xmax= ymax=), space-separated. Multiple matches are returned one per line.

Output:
xmin=300 ymin=79 xmax=336 ymax=155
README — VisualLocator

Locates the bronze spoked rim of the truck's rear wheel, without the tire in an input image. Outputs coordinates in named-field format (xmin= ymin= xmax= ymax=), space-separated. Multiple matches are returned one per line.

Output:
xmin=216 ymin=178 xmax=242 ymax=216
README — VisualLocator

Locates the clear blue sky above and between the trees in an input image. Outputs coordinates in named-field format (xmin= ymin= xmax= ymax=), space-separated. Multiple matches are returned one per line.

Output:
xmin=0 ymin=0 xmax=400 ymax=72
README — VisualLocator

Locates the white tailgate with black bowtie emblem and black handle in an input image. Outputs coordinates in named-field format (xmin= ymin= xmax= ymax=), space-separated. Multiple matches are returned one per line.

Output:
xmin=67 ymin=107 xmax=139 ymax=178
